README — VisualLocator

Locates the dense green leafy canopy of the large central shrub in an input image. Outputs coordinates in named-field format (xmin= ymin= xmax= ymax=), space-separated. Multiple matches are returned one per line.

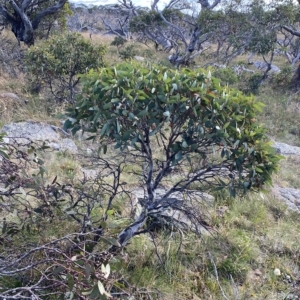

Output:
xmin=65 ymin=62 xmax=280 ymax=187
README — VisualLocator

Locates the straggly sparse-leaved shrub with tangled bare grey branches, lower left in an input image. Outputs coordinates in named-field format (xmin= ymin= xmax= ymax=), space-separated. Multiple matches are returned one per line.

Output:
xmin=0 ymin=133 xmax=119 ymax=299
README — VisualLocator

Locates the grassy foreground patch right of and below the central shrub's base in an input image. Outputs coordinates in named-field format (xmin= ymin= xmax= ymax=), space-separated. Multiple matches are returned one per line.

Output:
xmin=112 ymin=194 xmax=300 ymax=299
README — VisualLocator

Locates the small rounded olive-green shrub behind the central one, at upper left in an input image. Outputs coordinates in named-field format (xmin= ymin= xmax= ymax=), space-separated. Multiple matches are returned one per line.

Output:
xmin=25 ymin=33 xmax=105 ymax=103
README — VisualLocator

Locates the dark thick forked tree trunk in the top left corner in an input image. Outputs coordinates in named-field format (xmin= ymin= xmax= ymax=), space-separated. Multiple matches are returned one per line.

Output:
xmin=0 ymin=0 xmax=67 ymax=46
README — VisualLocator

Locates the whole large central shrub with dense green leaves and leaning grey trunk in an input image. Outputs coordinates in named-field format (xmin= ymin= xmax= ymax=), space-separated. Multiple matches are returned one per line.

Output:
xmin=65 ymin=62 xmax=279 ymax=246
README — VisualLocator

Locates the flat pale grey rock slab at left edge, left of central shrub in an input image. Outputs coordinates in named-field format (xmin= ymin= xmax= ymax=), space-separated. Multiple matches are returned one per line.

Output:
xmin=1 ymin=121 xmax=78 ymax=154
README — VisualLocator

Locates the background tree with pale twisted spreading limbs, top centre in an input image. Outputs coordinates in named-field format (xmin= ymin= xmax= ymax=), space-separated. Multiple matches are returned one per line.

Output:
xmin=122 ymin=0 xmax=221 ymax=66
